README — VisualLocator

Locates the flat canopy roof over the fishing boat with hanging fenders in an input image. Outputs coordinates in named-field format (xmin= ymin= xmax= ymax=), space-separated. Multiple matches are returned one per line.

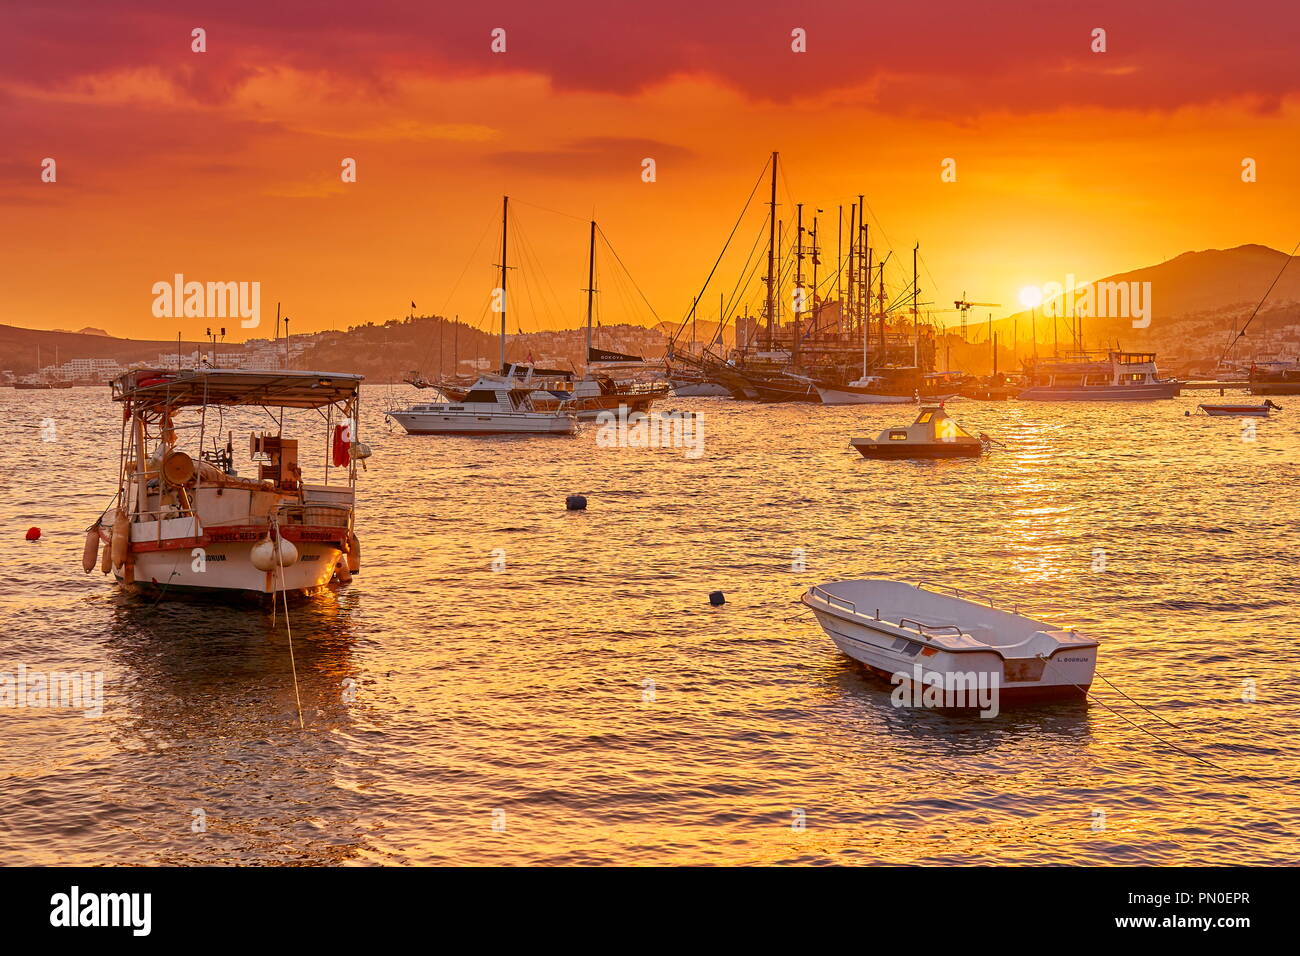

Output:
xmin=112 ymin=368 xmax=365 ymax=408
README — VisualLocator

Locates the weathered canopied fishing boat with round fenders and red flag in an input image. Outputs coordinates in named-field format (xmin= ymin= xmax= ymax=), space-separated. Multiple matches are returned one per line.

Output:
xmin=82 ymin=368 xmax=371 ymax=597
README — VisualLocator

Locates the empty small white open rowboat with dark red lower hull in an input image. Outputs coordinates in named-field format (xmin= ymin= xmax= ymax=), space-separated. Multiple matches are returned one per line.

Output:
xmin=801 ymin=579 xmax=1097 ymax=706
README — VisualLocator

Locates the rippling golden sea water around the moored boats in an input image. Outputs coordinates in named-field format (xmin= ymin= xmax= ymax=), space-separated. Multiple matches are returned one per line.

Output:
xmin=0 ymin=386 xmax=1300 ymax=864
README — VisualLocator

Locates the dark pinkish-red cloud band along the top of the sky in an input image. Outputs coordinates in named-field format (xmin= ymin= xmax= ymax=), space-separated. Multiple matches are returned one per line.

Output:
xmin=0 ymin=0 xmax=1300 ymax=116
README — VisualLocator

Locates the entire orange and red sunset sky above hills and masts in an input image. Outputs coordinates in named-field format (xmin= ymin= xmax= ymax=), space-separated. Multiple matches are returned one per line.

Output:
xmin=0 ymin=0 xmax=1300 ymax=341
